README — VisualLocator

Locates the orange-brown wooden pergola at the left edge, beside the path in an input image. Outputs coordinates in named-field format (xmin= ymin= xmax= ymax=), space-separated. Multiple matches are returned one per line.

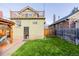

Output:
xmin=0 ymin=18 xmax=14 ymax=45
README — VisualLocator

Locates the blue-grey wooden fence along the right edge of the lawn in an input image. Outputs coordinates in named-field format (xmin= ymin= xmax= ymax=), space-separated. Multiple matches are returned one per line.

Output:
xmin=56 ymin=28 xmax=79 ymax=44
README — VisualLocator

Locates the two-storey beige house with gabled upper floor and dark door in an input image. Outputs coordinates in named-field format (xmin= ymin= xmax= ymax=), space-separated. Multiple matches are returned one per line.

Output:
xmin=10 ymin=6 xmax=45 ymax=40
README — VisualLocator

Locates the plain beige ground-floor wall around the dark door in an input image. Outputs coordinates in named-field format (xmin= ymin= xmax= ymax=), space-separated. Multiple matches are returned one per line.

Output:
xmin=13 ymin=19 xmax=44 ymax=40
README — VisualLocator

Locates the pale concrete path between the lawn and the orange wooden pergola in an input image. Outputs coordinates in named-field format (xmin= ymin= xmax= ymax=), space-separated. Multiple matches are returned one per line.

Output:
xmin=2 ymin=40 xmax=26 ymax=56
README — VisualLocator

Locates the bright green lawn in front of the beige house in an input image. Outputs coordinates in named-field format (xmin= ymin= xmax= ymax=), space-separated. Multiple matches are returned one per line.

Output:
xmin=12 ymin=37 xmax=79 ymax=56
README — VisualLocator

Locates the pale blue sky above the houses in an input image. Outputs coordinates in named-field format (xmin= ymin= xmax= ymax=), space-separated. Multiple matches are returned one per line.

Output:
xmin=0 ymin=3 xmax=79 ymax=25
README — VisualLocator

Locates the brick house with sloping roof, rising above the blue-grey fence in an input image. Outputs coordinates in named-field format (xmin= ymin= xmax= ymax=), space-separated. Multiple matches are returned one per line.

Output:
xmin=49 ymin=8 xmax=79 ymax=29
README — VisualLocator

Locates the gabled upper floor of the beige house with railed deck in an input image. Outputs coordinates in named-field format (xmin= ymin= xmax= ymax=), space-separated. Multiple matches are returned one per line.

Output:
xmin=10 ymin=6 xmax=45 ymax=18
